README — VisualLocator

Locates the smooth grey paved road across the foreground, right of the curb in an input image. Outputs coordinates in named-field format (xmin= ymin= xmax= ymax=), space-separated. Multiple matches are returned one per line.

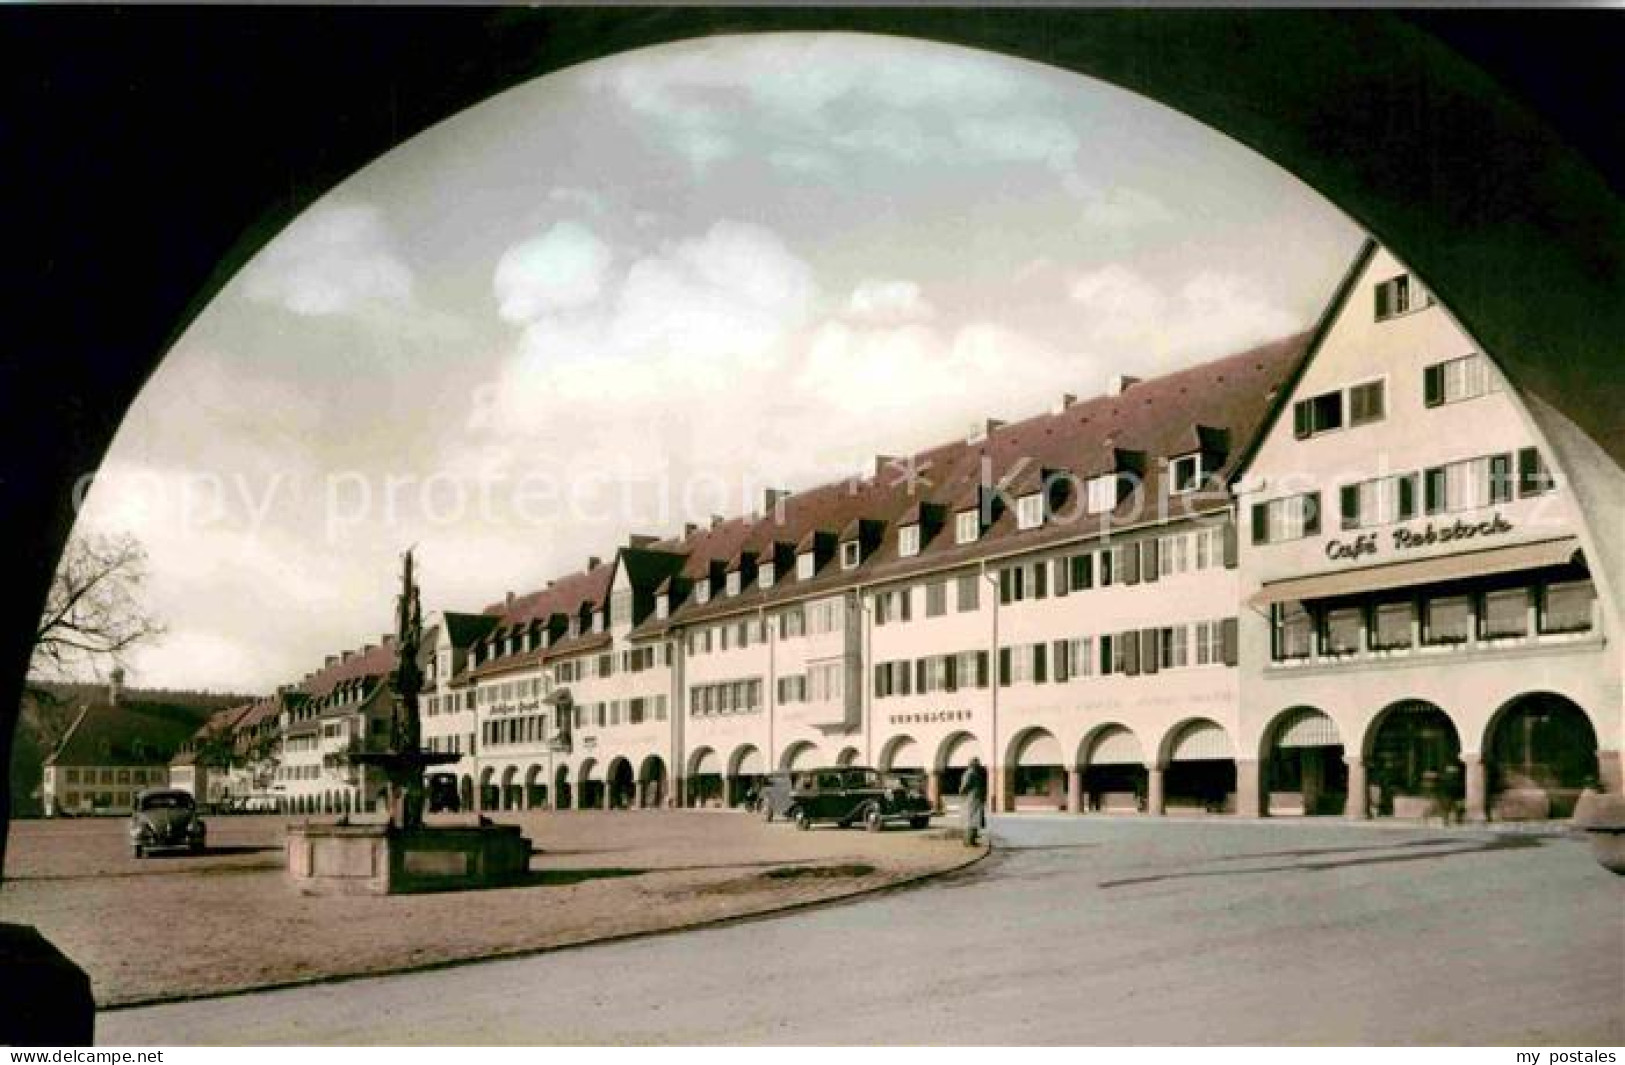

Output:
xmin=98 ymin=818 xmax=1625 ymax=1045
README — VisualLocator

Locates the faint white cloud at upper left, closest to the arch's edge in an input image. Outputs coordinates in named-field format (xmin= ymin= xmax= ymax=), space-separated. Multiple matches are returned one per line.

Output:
xmin=241 ymin=203 xmax=413 ymax=317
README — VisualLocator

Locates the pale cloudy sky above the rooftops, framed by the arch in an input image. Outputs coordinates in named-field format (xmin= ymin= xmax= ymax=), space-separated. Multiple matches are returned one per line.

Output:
xmin=81 ymin=36 xmax=1360 ymax=691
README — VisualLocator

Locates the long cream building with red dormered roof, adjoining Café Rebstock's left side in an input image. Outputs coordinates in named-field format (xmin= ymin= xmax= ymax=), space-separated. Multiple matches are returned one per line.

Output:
xmin=453 ymin=338 xmax=1303 ymax=811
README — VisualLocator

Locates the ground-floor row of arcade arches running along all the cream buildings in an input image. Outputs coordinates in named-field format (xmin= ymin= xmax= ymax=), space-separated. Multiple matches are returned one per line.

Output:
xmin=289 ymin=693 xmax=1617 ymax=819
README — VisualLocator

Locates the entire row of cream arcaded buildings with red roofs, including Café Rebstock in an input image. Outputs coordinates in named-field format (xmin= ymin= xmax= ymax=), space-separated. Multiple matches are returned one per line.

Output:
xmin=186 ymin=246 xmax=1625 ymax=818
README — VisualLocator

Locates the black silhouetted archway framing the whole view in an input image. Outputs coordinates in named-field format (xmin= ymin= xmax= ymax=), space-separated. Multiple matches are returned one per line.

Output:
xmin=0 ymin=8 xmax=1625 ymax=860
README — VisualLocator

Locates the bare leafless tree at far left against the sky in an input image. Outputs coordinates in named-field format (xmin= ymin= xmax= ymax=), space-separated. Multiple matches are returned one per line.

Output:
xmin=29 ymin=535 xmax=164 ymax=678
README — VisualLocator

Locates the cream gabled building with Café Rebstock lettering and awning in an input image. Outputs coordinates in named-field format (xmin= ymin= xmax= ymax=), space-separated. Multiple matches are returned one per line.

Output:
xmin=1238 ymin=246 xmax=1622 ymax=819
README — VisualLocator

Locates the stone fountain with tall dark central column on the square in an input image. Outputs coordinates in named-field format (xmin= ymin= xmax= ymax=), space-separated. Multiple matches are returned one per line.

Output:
xmin=288 ymin=551 xmax=530 ymax=894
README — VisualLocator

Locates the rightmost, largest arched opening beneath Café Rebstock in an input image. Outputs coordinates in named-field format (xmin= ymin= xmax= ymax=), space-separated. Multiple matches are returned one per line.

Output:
xmin=1484 ymin=691 xmax=1597 ymax=821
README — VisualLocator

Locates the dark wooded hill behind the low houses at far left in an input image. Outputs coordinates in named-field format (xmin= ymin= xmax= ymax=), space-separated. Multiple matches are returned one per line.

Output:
xmin=10 ymin=681 xmax=258 ymax=816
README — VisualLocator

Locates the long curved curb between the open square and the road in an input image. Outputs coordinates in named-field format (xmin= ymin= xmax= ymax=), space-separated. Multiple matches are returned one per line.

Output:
xmin=96 ymin=844 xmax=993 ymax=1016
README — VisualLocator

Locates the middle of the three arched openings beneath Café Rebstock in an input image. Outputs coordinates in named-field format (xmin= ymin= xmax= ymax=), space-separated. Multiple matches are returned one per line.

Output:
xmin=1367 ymin=699 xmax=1466 ymax=818
